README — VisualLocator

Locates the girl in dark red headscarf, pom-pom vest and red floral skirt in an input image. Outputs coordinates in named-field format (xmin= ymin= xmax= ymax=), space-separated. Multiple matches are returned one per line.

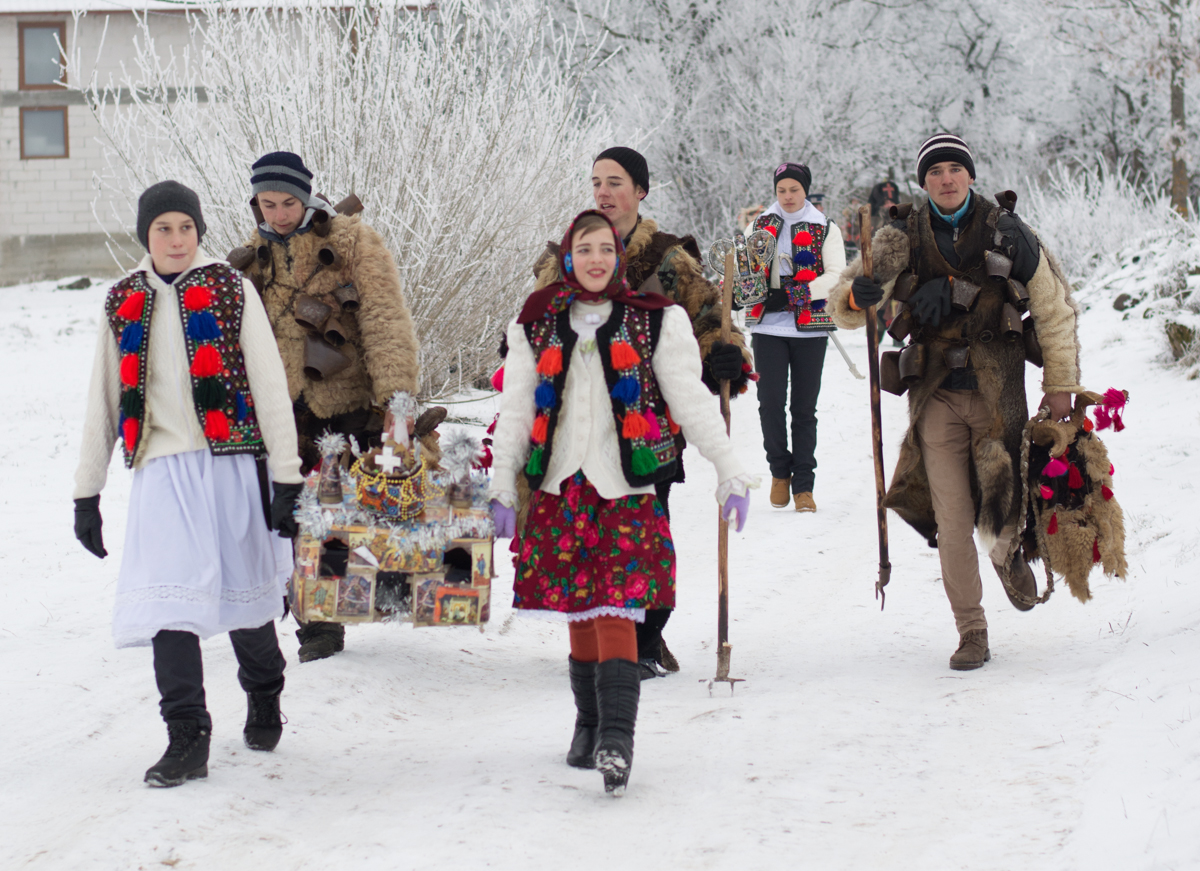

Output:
xmin=491 ymin=210 xmax=756 ymax=794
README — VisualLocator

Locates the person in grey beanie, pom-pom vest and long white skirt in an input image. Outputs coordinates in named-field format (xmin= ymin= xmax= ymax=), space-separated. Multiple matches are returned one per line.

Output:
xmin=74 ymin=181 xmax=302 ymax=786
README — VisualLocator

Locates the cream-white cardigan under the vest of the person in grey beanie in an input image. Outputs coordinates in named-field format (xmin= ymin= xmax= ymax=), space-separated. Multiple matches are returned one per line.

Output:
xmin=74 ymin=248 xmax=304 ymax=499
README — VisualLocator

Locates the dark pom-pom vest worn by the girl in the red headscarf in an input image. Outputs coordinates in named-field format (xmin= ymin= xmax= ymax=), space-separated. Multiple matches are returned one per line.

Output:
xmin=524 ymin=302 xmax=679 ymax=489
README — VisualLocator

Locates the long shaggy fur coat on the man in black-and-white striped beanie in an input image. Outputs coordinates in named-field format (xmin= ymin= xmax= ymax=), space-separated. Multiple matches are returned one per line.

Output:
xmin=829 ymin=198 xmax=1084 ymax=566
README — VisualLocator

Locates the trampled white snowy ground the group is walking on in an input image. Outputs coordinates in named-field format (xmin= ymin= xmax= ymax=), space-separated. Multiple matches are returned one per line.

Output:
xmin=0 ymin=274 xmax=1200 ymax=871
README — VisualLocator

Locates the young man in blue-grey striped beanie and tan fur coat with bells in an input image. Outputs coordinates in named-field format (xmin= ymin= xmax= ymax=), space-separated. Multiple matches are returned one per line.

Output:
xmin=234 ymin=151 xmax=419 ymax=662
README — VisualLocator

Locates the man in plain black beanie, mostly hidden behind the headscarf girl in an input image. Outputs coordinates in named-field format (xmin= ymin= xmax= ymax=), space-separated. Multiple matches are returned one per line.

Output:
xmin=534 ymin=145 xmax=756 ymax=678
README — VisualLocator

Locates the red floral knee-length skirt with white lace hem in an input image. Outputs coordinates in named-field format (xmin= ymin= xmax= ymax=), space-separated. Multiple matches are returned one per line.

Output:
xmin=512 ymin=471 xmax=674 ymax=620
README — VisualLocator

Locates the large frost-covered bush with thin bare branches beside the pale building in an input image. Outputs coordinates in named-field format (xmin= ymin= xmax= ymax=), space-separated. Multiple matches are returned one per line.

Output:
xmin=71 ymin=0 xmax=607 ymax=396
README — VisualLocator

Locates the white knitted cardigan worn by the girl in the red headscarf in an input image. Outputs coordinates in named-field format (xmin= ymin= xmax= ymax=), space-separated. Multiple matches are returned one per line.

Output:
xmin=490 ymin=301 xmax=750 ymax=506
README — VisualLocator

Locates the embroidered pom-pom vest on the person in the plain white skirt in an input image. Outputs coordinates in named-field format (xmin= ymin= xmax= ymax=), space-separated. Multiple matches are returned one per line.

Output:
xmin=104 ymin=264 xmax=266 ymax=468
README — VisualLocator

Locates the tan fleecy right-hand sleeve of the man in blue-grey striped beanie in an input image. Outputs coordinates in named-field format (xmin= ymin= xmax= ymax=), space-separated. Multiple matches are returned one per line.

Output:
xmin=350 ymin=224 xmax=420 ymax=404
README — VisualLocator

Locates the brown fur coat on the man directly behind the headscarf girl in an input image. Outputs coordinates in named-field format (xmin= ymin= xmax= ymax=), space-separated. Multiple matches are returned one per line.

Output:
xmin=534 ymin=218 xmax=754 ymax=396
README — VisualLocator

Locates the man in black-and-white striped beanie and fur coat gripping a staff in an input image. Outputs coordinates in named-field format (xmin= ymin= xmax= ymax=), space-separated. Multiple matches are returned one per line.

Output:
xmin=830 ymin=133 xmax=1082 ymax=671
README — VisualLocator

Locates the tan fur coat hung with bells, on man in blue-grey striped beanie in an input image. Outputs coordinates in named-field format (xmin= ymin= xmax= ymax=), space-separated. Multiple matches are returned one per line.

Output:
xmin=236 ymin=215 xmax=420 ymax=418
